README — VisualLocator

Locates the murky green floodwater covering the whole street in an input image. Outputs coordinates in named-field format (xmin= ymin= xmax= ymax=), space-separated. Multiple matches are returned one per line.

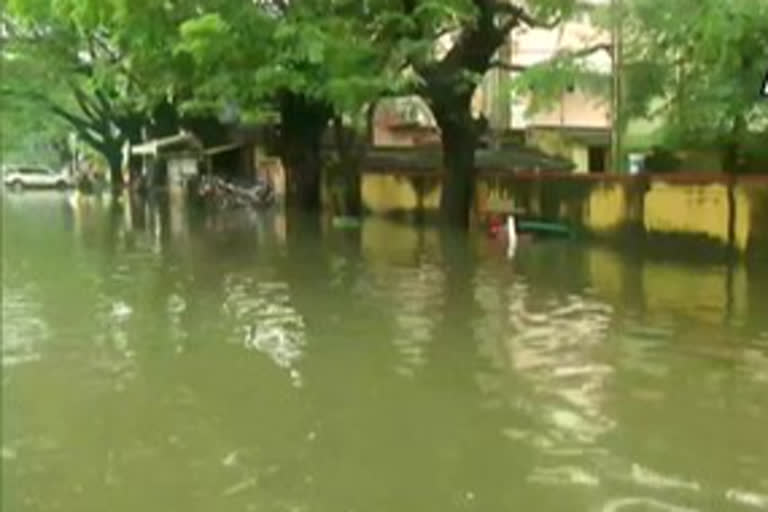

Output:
xmin=2 ymin=193 xmax=768 ymax=512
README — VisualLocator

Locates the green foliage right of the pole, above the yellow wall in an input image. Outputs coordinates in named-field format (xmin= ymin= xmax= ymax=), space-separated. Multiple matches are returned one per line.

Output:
xmin=625 ymin=0 xmax=768 ymax=147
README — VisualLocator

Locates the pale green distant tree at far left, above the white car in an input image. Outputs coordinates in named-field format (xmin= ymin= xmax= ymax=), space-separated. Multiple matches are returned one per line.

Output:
xmin=0 ymin=4 xmax=147 ymax=187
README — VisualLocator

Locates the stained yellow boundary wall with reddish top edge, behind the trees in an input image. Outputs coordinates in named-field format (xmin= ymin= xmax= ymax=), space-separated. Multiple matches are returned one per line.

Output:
xmin=316 ymin=172 xmax=768 ymax=255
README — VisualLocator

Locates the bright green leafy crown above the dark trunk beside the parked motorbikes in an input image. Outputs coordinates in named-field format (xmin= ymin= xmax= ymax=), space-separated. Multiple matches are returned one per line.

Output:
xmin=176 ymin=0 xmax=402 ymax=118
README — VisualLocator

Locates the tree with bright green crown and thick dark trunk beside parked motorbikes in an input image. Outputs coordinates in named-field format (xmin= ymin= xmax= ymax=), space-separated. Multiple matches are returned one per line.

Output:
xmin=177 ymin=0 xmax=400 ymax=209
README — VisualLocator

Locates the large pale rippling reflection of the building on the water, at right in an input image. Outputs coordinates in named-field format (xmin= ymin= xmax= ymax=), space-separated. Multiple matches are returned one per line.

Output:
xmin=478 ymin=279 xmax=616 ymax=496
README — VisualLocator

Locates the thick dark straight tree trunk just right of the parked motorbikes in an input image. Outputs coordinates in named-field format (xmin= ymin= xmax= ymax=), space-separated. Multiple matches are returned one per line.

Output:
xmin=280 ymin=92 xmax=333 ymax=210
